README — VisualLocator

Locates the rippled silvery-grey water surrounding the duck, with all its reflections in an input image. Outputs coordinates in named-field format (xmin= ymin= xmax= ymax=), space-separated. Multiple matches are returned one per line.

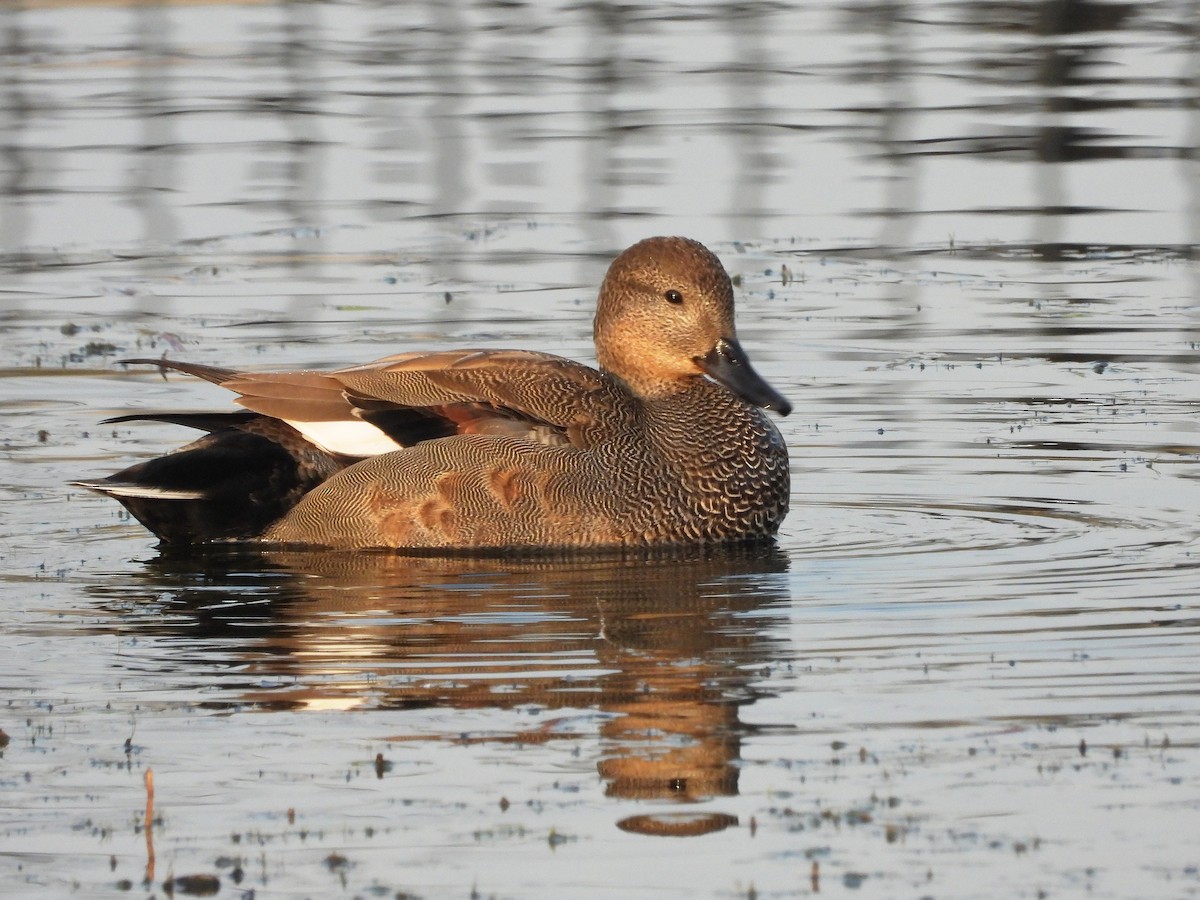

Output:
xmin=0 ymin=0 xmax=1200 ymax=898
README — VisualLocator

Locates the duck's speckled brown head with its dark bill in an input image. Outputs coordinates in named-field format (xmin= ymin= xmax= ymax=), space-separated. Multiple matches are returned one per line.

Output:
xmin=595 ymin=238 xmax=792 ymax=415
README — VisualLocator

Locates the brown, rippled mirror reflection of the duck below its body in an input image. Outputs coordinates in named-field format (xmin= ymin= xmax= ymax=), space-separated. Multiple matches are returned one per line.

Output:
xmin=87 ymin=548 xmax=786 ymax=820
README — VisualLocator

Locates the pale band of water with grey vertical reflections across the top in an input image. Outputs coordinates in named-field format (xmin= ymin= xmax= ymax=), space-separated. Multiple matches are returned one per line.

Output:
xmin=0 ymin=0 xmax=1200 ymax=262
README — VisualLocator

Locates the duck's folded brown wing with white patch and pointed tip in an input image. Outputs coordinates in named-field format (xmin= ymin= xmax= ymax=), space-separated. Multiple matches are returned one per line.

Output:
xmin=130 ymin=350 xmax=630 ymax=456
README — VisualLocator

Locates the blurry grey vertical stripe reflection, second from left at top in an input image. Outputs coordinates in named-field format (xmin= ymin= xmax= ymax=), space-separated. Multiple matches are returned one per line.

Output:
xmin=127 ymin=0 xmax=179 ymax=264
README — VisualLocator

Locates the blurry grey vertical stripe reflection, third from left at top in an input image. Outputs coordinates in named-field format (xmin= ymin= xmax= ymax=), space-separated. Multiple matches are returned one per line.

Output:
xmin=278 ymin=0 xmax=328 ymax=313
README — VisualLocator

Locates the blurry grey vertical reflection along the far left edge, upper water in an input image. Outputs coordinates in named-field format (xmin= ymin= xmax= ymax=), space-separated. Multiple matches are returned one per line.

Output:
xmin=0 ymin=4 xmax=32 ymax=251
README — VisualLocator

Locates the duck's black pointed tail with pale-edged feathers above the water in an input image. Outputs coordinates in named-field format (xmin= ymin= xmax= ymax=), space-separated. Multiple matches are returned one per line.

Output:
xmin=71 ymin=413 xmax=355 ymax=545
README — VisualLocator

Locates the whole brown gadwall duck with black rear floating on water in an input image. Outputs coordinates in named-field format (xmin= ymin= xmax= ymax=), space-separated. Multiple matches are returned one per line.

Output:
xmin=74 ymin=238 xmax=791 ymax=552
